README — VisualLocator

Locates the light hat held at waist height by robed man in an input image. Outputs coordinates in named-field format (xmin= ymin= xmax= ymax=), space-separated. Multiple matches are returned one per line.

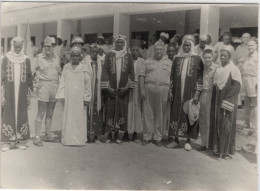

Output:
xmin=183 ymin=99 xmax=200 ymax=125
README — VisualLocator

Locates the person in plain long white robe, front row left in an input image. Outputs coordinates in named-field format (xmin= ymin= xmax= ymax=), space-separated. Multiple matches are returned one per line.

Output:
xmin=56 ymin=47 xmax=91 ymax=146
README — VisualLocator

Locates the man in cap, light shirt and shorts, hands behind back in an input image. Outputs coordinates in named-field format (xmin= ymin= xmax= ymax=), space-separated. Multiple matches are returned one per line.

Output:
xmin=33 ymin=36 xmax=61 ymax=146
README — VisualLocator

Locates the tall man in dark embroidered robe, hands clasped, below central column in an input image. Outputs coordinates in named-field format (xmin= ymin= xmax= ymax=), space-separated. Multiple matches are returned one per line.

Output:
xmin=101 ymin=35 xmax=134 ymax=144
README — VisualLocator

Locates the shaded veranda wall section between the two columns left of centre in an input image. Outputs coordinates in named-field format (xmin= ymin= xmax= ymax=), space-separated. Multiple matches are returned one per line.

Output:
xmin=81 ymin=17 xmax=114 ymax=36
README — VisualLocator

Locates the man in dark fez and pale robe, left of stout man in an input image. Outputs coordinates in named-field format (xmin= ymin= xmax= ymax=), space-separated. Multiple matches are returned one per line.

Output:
xmin=127 ymin=40 xmax=144 ymax=143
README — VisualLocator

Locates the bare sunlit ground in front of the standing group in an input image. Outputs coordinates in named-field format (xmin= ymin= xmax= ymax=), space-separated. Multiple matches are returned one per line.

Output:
xmin=0 ymin=96 xmax=257 ymax=191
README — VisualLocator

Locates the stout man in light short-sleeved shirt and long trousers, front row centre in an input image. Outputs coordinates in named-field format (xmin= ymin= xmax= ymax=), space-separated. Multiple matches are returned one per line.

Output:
xmin=139 ymin=40 xmax=172 ymax=147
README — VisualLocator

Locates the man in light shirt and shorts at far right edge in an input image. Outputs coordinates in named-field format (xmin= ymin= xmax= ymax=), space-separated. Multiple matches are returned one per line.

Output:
xmin=241 ymin=40 xmax=258 ymax=128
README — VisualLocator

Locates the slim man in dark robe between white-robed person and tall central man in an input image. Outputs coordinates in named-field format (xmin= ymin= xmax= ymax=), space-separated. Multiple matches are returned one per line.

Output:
xmin=84 ymin=43 xmax=104 ymax=144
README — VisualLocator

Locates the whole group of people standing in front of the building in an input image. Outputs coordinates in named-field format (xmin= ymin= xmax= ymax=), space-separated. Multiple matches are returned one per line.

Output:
xmin=1 ymin=33 xmax=257 ymax=158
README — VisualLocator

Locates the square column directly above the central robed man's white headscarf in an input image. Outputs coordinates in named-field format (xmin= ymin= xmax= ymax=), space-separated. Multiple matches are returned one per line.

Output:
xmin=113 ymin=12 xmax=131 ymax=44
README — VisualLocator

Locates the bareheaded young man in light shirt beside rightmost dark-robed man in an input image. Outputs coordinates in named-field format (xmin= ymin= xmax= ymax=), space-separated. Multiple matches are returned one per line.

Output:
xmin=199 ymin=49 xmax=217 ymax=151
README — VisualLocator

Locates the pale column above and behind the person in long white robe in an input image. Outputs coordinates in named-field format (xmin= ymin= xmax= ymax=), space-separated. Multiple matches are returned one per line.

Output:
xmin=57 ymin=20 xmax=71 ymax=42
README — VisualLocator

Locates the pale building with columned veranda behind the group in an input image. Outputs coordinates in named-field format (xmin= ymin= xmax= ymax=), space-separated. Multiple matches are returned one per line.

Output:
xmin=1 ymin=2 xmax=258 ymax=52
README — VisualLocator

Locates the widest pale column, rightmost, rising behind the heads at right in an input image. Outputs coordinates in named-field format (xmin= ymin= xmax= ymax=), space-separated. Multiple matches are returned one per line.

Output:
xmin=200 ymin=4 xmax=219 ymax=44
